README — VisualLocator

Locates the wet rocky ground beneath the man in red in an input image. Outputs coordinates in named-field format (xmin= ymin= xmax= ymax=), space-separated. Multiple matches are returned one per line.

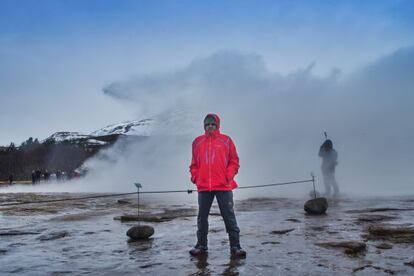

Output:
xmin=0 ymin=192 xmax=414 ymax=275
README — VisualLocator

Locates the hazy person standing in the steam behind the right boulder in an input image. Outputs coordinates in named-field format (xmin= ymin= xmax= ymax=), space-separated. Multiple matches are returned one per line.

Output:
xmin=319 ymin=139 xmax=339 ymax=197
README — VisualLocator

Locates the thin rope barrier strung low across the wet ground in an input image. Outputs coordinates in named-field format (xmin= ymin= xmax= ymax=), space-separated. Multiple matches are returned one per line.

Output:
xmin=0 ymin=176 xmax=315 ymax=207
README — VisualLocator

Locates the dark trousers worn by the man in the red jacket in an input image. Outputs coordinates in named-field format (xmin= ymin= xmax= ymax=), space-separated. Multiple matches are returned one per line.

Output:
xmin=197 ymin=191 xmax=240 ymax=247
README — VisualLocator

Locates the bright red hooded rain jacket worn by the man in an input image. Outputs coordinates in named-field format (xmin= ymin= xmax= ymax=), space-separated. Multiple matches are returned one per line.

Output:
xmin=190 ymin=114 xmax=240 ymax=192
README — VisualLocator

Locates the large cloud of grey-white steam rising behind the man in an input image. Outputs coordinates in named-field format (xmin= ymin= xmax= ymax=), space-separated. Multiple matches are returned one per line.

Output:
xmin=4 ymin=47 xmax=414 ymax=197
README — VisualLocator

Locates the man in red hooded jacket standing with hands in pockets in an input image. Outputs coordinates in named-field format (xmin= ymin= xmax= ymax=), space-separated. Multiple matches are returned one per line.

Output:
xmin=190 ymin=114 xmax=246 ymax=257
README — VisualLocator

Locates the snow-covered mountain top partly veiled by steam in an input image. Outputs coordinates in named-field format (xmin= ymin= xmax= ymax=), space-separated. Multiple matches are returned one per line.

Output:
xmin=90 ymin=119 xmax=154 ymax=137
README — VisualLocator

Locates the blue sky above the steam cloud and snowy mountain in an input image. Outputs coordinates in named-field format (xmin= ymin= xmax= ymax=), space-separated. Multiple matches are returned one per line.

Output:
xmin=0 ymin=0 xmax=414 ymax=145
